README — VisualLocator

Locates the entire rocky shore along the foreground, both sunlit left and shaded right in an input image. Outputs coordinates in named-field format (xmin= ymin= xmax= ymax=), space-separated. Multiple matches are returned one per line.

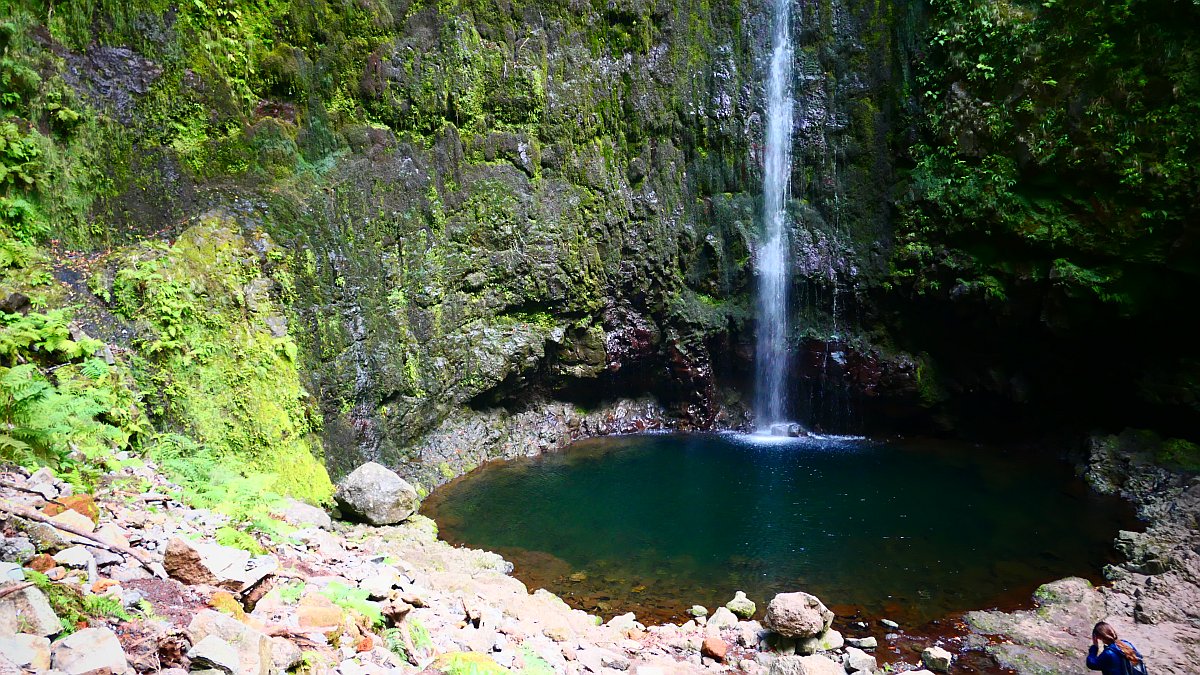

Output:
xmin=0 ymin=434 xmax=1200 ymax=675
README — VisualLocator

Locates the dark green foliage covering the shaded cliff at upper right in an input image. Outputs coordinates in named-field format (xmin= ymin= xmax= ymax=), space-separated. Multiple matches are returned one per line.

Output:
xmin=893 ymin=0 xmax=1200 ymax=305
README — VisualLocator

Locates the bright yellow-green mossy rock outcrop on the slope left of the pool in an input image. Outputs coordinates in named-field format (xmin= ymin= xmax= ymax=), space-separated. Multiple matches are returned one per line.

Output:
xmin=100 ymin=216 xmax=332 ymax=502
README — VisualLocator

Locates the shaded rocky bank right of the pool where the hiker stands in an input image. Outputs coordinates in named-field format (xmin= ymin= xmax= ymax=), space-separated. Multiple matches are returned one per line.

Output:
xmin=966 ymin=431 xmax=1200 ymax=675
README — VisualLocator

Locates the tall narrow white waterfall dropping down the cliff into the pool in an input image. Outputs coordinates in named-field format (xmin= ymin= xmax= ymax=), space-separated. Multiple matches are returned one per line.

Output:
xmin=755 ymin=0 xmax=792 ymax=430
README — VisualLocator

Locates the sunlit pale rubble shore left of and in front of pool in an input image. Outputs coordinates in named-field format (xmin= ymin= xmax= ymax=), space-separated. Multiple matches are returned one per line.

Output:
xmin=0 ymin=456 xmax=949 ymax=675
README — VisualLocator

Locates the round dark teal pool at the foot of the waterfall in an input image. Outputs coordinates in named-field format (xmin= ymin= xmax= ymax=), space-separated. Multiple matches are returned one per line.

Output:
xmin=424 ymin=434 xmax=1135 ymax=626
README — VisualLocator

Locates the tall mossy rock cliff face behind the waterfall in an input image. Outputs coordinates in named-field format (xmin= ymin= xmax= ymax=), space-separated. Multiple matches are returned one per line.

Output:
xmin=4 ymin=0 xmax=912 ymax=484
